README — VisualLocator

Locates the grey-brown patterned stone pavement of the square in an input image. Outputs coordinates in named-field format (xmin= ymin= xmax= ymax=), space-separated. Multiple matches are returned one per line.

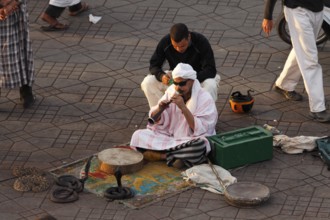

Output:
xmin=0 ymin=0 xmax=330 ymax=220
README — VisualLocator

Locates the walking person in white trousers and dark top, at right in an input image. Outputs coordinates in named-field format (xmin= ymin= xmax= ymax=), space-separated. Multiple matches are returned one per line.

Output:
xmin=262 ymin=0 xmax=330 ymax=122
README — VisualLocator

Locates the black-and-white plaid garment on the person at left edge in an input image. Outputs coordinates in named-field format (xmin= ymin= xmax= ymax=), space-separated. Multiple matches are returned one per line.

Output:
xmin=0 ymin=0 xmax=34 ymax=88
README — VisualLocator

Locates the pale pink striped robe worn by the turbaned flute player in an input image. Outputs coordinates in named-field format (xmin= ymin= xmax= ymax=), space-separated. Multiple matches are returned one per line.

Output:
xmin=130 ymin=80 xmax=218 ymax=153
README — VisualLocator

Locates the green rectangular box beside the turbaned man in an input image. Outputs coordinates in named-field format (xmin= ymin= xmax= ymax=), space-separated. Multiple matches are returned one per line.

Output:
xmin=208 ymin=126 xmax=273 ymax=169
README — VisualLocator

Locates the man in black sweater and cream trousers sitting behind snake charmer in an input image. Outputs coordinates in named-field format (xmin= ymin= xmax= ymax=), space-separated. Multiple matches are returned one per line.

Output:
xmin=141 ymin=23 xmax=220 ymax=108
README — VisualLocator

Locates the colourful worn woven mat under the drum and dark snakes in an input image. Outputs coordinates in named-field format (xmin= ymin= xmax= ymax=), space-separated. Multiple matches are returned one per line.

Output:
xmin=50 ymin=156 xmax=193 ymax=209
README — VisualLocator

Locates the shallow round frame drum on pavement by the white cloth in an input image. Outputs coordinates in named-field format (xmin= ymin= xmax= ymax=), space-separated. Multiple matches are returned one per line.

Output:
xmin=224 ymin=182 xmax=270 ymax=208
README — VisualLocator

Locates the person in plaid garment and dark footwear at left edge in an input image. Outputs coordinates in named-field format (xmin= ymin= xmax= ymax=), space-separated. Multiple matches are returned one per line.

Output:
xmin=0 ymin=0 xmax=35 ymax=108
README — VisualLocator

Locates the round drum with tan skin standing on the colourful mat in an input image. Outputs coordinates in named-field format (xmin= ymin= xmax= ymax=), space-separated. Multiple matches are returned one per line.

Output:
xmin=98 ymin=147 xmax=143 ymax=175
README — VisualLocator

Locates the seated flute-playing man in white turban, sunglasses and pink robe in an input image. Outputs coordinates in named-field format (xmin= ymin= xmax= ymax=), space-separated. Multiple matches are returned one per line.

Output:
xmin=130 ymin=63 xmax=218 ymax=167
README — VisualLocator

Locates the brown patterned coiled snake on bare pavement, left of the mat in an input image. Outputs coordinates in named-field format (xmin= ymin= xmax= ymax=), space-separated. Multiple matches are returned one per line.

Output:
xmin=12 ymin=167 xmax=50 ymax=193
